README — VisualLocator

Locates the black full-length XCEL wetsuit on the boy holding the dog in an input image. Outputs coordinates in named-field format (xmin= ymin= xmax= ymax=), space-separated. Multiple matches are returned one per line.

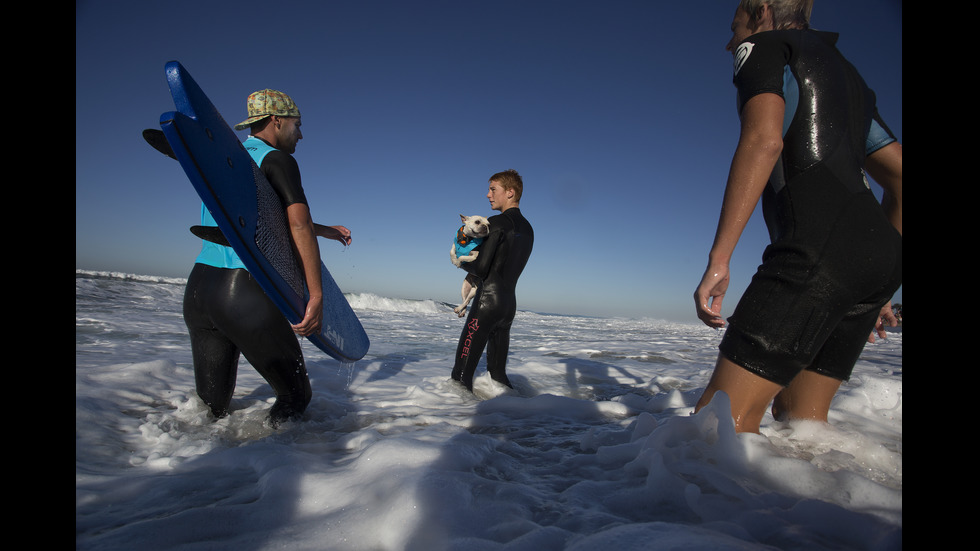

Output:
xmin=452 ymin=208 xmax=534 ymax=390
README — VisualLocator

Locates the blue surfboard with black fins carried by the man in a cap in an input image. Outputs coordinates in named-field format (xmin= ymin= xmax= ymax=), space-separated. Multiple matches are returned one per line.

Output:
xmin=160 ymin=61 xmax=370 ymax=362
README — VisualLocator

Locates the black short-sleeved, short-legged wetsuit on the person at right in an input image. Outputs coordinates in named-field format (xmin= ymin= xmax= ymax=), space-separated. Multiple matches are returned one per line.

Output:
xmin=720 ymin=30 xmax=902 ymax=385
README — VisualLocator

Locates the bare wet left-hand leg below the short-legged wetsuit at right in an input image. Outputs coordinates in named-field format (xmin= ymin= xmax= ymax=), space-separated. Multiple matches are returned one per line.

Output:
xmin=694 ymin=356 xmax=783 ymax=433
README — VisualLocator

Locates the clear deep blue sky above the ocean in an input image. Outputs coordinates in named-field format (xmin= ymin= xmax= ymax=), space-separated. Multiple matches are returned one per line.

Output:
xmin=75 ymin=0 xmax=902 ymax=321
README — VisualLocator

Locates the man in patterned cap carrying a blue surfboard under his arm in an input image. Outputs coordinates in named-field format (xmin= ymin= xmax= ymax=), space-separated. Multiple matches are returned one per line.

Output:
xmin=184 ymin=89 xmax=350 ymax=426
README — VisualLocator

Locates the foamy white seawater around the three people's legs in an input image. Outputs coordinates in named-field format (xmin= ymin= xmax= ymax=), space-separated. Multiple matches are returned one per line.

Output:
xmin=75 ymin=271 xmax=902 ymax=551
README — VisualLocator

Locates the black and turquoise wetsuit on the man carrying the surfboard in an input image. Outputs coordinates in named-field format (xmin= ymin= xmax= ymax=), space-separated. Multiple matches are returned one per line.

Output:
xmin=184 ymin=136 xmax=312 ymax=425
